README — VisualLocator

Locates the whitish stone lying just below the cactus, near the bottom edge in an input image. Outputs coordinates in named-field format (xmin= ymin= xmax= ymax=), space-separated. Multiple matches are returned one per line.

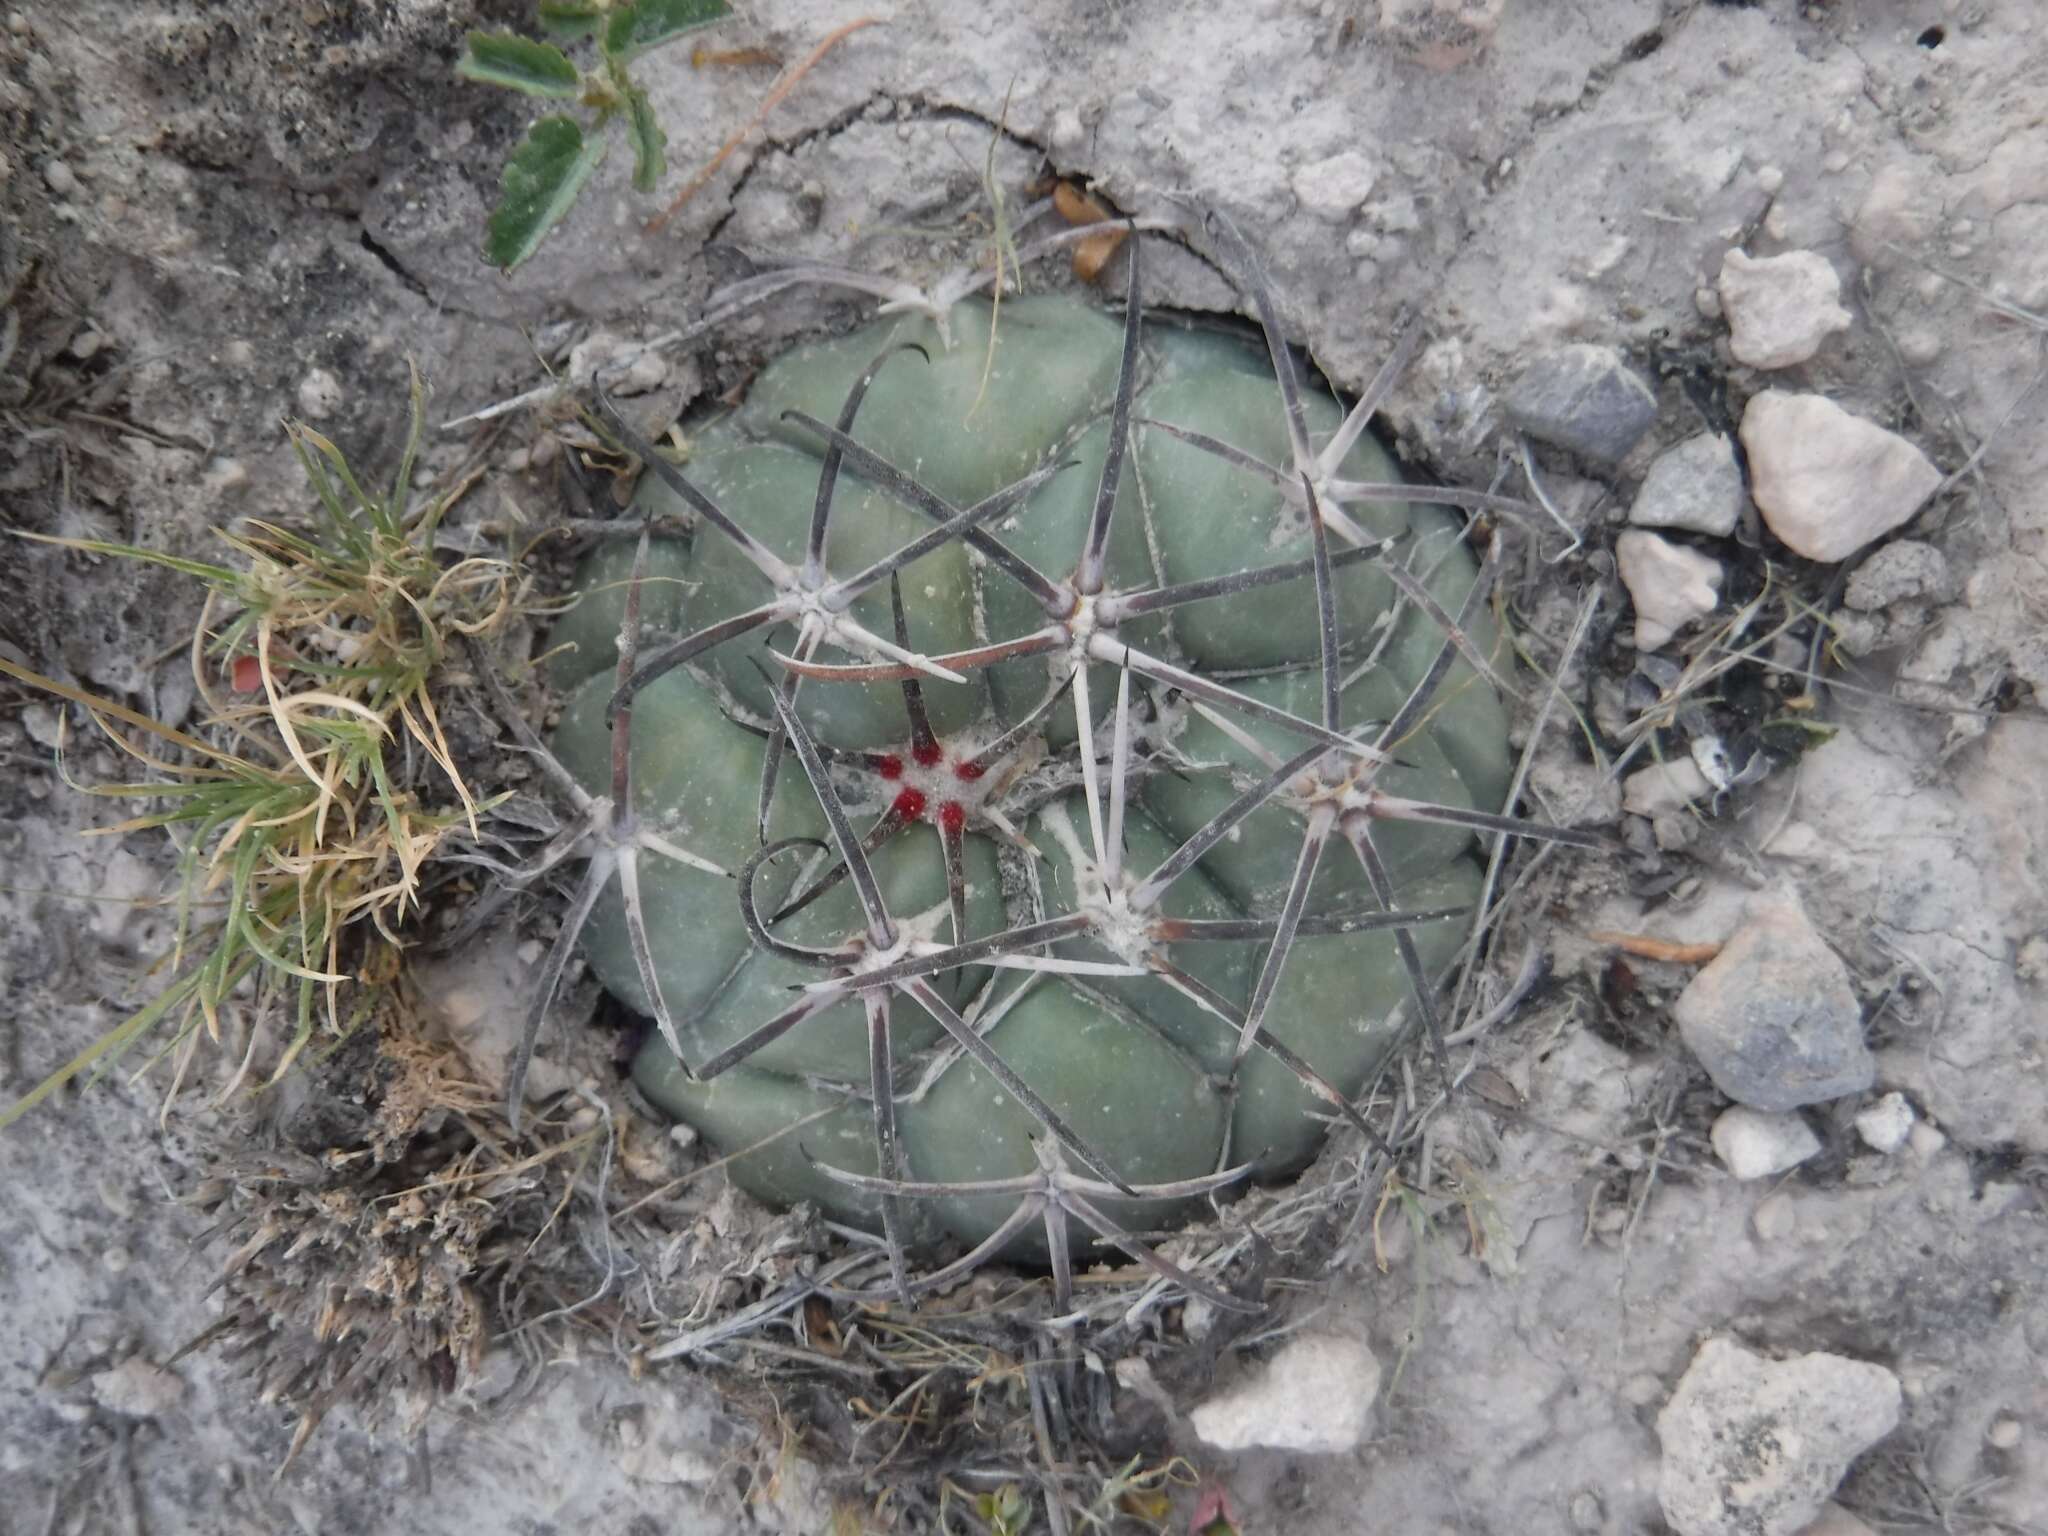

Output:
xmin=1190 ymin=1333 xmax=1380 ymax=1454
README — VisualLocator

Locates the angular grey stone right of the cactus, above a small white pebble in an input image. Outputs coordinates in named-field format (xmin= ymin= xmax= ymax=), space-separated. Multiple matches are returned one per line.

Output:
xmin=1671 ymin=895 xmax=1878 ymax=1110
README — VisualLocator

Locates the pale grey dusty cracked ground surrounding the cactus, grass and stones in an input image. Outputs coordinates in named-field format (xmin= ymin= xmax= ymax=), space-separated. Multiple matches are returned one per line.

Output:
xmin=0 ymin=0 xmax=2048 ymax=1534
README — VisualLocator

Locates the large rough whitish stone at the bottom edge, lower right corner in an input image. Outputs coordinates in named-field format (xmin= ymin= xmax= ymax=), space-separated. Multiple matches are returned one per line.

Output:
xmin=1657 ymin=1339 xmax=1901 ymax=1536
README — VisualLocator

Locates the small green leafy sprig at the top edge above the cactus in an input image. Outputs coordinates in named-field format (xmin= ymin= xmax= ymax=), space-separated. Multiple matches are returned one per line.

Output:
xmin=457 ymin=0 xmax=731 ymax=272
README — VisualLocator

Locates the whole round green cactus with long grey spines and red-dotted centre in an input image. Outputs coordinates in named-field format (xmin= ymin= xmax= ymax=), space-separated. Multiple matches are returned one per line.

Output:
xmin=532 ymin=228 xmax=1581 ymax=1305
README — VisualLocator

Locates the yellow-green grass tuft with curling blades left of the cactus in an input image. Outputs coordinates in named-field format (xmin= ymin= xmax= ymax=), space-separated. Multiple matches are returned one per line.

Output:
xmin=0 ymin=360 xmax=522 ymax=1128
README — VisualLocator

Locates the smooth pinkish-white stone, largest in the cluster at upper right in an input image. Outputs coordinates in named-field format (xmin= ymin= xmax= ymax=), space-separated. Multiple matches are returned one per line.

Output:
xmin=1743 ymin=389 xmax=1942 ymax=561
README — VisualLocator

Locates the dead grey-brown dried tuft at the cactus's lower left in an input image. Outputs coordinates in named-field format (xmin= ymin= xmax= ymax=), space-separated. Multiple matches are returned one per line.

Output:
xmin=180 ymin=987 xmax=608 ymax=1470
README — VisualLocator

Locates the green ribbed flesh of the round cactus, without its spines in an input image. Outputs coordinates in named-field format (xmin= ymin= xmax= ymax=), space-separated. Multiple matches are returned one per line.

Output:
xmin=553 ymin=299 xmax=1507 ymax=1251
